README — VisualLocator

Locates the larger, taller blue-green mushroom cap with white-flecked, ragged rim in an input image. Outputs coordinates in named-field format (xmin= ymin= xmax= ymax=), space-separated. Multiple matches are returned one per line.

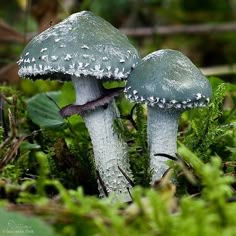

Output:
xmin=18 ymin=11 xmax=140 ymax=80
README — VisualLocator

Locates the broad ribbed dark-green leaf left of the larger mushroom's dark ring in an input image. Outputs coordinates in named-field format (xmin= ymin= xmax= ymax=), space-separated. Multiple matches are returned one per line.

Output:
xmin=27 ymin=91 xmax=66 ymax=129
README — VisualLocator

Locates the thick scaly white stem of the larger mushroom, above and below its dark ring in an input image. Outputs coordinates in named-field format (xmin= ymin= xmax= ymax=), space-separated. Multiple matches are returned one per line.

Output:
xmin=72 ymin=76 xmax=132 ymax=201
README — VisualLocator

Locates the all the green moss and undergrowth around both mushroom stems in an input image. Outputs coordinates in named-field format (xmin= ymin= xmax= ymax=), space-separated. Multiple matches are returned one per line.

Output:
xmin=0 ymin=80 xmax=236 ymax=236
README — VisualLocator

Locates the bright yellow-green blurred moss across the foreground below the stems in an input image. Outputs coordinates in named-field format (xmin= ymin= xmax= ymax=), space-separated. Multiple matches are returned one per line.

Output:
xmin=1 ymin=145 xmax=236 ymax=236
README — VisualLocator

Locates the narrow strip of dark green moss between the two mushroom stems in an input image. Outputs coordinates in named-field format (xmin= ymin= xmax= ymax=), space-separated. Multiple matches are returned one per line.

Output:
xmin=114 ymin=100 xmax=151 ymax=186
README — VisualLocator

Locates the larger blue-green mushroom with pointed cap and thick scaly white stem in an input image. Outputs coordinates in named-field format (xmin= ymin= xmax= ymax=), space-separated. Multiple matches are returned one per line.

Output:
xmin=18 ymin=11 xmax=140 ymax=201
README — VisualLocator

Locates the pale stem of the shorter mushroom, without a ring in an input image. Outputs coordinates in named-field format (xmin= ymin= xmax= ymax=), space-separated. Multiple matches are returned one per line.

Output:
xmin=147 ymin=107 xmax=181 ymax=184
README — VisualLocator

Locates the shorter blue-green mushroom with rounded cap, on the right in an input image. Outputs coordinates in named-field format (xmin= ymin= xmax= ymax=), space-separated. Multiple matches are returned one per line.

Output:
xmin=125 ymin=49 xmax=212 ymax=183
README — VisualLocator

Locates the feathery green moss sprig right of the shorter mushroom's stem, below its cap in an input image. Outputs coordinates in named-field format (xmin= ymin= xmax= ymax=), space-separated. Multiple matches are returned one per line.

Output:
xmin=184 ymin=83 xmax=234 ymax=160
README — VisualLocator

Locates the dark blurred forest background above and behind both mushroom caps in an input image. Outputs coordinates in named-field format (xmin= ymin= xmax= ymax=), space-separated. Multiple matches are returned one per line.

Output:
xmin=0 ymin=0 xmax=236 ymax=83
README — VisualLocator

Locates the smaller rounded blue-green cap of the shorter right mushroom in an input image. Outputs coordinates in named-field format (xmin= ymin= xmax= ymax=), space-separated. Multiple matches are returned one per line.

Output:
xmin=125 ymin=49 xmax=212 ymax=109
